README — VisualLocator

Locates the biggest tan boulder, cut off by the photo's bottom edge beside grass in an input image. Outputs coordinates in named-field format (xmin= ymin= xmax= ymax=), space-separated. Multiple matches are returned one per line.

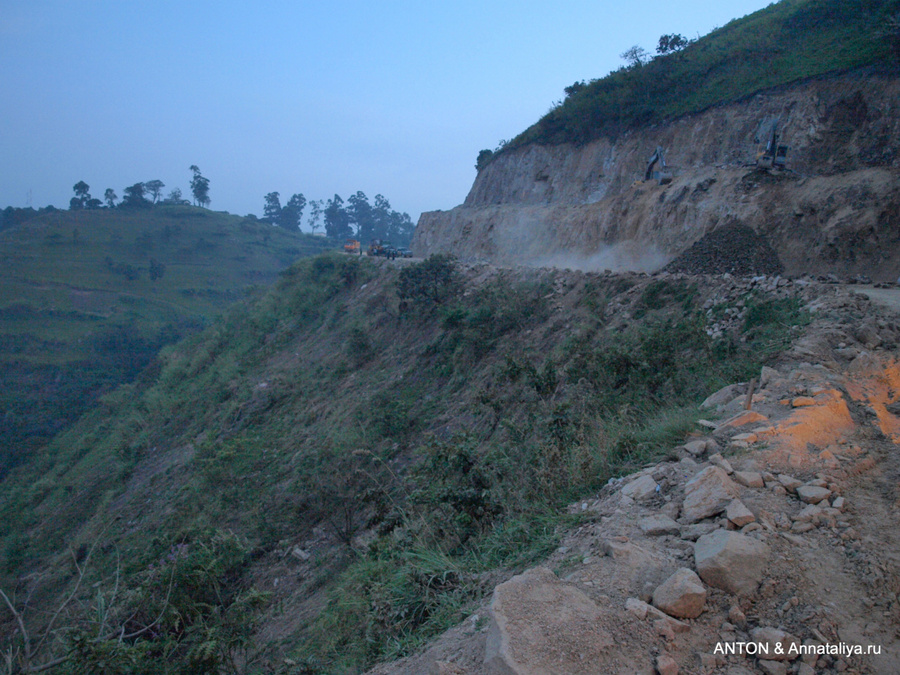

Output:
xmin=484 ymin=567 xmax=613 ymax=675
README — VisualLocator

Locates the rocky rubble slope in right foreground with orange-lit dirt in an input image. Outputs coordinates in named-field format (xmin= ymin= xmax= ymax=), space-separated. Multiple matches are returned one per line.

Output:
xmin=371 ymin=277 xmax=900 ymax=675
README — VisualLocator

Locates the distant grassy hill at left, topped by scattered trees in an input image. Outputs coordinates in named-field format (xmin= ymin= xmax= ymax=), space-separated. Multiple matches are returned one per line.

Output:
xmin=0 ymin=206 xmax=328 ymax=476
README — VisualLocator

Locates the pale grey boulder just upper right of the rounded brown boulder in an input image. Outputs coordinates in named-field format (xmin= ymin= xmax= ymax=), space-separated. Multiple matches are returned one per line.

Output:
xmin=694 ymin=530 xmax=769 ymax=596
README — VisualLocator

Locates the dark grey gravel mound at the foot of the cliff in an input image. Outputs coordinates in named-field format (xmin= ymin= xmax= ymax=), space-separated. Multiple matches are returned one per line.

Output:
xmin=664 ymin=223 xmax=784 ymax=275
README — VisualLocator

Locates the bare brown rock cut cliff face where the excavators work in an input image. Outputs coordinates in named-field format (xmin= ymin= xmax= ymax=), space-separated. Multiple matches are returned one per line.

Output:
xmin=413 ymin=69 xmax=900 ymax=280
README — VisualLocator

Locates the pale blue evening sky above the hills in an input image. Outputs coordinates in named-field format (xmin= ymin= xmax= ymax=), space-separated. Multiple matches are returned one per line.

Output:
xmin=0 ymin=0 xmax=770 ymax=227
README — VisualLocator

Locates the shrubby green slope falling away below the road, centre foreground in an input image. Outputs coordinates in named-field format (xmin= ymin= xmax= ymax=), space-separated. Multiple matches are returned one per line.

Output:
xmin=0 ymin=254 xmax=802 ymax=675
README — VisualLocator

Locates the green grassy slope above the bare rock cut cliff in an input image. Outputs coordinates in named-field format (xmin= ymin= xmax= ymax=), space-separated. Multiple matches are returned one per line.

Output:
xmin=492 ymin=0 xmax=900 ymax=156
